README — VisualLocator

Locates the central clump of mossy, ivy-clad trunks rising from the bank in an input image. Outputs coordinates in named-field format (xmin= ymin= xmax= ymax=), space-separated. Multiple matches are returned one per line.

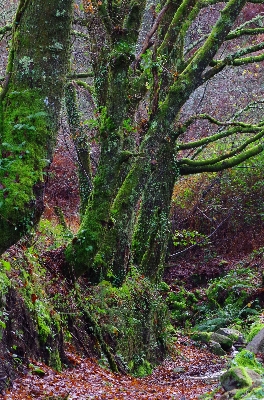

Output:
xmin=66 ymin=0 xmax=261 ymax=285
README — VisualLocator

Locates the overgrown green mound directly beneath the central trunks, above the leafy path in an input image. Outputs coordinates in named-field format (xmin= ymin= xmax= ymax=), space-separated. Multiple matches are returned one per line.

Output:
xmin=87 ymin=270 xmax=170 ymax=376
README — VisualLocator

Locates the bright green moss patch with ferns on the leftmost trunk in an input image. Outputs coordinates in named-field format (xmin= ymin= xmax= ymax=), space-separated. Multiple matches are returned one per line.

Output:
xmin=0 ymin=90 xmax=49 ymax=242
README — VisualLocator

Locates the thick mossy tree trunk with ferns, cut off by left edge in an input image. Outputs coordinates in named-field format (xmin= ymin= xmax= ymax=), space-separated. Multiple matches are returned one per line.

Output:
xmin=0 ymin=0 xmax=73 ymax=252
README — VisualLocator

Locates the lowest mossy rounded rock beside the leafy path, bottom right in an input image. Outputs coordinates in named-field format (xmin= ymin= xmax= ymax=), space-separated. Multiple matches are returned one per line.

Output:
xmin=220 ymin=367 xmax=253 ymax=392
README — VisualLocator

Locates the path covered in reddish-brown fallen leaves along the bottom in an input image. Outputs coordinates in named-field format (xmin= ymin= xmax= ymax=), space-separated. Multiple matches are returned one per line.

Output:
xmin=0 ymin=337 xmax=225 ymax=400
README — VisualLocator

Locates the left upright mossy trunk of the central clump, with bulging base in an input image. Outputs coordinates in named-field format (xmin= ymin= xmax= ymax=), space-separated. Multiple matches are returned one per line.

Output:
xmin=66 ymin=1 xmax=145 ymax=282
